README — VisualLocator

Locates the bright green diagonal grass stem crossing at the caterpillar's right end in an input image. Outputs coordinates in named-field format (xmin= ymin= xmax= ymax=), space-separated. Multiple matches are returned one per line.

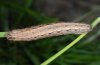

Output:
xmin=41 ymin=17 xmax=100 ymax=65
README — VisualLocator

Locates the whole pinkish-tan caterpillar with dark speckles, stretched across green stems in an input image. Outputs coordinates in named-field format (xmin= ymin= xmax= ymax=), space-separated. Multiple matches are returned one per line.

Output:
xmin=7 ymin=22 xmax=91 ymax=41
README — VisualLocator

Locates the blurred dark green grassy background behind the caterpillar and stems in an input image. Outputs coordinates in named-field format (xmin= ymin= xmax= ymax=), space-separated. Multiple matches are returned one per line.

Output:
xmin=0 ymin=0 xmax=100 ymax=65
